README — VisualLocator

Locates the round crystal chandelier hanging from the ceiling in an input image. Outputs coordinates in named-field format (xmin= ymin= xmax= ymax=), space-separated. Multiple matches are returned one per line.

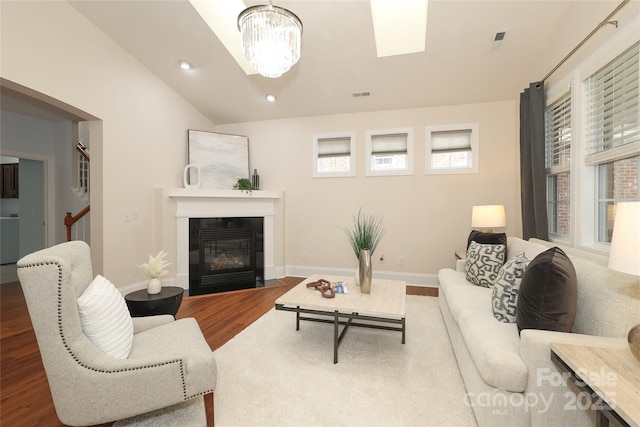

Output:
xmin=238 ymin=2 xmax=302 ymax=78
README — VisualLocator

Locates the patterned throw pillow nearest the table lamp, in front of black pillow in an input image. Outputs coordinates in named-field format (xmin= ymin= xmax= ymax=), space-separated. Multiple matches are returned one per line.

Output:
xmin=464 ymin=242 xmax=506 ymax=288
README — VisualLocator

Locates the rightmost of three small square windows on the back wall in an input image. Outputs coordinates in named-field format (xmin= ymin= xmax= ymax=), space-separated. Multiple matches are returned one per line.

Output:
xmin=425 ymin=123 xmax=480 ymax=174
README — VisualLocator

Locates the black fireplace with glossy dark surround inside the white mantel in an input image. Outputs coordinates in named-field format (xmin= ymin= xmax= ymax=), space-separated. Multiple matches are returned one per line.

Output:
xmin=189 ymin=217 xmax=264 ymax=295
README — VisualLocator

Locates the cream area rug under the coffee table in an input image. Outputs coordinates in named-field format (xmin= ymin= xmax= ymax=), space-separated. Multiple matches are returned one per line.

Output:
xmin=214 ymin=295 xmax=476 ymax=426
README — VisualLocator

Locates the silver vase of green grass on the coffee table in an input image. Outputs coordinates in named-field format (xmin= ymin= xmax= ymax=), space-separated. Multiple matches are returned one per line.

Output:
xmin=345 ymin=209 xmax=385 ymax=294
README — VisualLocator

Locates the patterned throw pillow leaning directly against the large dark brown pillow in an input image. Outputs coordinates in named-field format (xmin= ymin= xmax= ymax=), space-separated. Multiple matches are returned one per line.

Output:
xmin=491 ymin=254 xmax=529 ymax=323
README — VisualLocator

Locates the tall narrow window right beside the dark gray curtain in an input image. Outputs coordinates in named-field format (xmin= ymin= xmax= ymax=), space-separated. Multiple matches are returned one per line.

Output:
xmin=544 ymin=92 xmax=571 ymax=240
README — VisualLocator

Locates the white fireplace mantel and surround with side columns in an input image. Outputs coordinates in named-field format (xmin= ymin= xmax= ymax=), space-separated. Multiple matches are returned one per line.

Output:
xmin=165 ymin=188 xmax=284 ymax=289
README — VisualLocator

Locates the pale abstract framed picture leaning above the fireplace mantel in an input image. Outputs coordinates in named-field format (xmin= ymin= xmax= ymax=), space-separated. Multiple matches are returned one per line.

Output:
xmin=189 ymin=129 xmax=249 ymax=190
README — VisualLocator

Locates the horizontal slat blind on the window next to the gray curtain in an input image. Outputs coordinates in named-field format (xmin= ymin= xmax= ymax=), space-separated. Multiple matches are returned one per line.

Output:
xmin=544 ymin=92 xmax=571 ymax=173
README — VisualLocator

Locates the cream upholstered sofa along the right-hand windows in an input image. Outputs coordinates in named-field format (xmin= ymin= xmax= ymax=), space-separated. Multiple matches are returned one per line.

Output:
xmin=438 ymin=237 xmax=640 ymax=426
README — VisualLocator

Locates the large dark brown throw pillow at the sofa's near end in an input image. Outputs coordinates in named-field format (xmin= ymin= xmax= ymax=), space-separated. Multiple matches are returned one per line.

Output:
xmin=516 ymin=247 xmax=578 ymax=333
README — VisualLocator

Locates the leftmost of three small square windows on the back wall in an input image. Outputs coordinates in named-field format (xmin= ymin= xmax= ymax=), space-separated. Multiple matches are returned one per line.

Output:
xmin=313 ymin=132 xmax=356 ymax=177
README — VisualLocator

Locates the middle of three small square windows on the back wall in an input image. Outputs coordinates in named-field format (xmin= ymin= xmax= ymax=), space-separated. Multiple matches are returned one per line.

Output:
xmin=366 ymin=128 xmax=413 ymax=176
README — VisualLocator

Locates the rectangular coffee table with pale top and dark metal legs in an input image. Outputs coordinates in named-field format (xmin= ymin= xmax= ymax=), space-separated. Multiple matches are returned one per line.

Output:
xmin=275 ymin=275 xmax=407 ymax=363
